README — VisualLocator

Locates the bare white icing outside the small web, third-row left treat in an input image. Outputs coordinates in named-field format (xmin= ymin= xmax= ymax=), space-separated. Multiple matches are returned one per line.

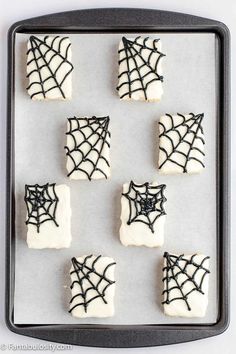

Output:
xmin=27 ymin=185 xmax=71 ymax=249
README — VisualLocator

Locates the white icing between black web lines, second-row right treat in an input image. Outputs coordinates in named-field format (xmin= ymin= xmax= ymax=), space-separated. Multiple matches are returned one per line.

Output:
xmin=158 ymin=114 xmax=204 ymax=174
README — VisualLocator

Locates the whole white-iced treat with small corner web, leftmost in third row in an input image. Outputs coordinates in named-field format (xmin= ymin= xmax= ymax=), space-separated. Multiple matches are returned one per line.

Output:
xmin=24 ymin=183 xmax=71 ymax=249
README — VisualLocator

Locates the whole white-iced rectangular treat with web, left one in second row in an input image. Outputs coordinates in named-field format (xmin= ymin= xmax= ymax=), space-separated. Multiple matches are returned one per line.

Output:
xmin=65 ymin=116 xmax=111 ymax=180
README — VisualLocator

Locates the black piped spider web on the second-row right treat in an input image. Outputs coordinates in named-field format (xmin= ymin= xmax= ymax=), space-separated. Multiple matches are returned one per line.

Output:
xmin=159 ymin=113 xmax=205 ymax=173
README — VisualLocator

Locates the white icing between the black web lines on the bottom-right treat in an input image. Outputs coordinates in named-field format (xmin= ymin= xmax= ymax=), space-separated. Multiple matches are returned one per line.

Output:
xmin=164 ymin=254 xmax=209 ymax=317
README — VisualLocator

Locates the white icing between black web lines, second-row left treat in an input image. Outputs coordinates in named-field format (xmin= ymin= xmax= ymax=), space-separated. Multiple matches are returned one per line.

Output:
xmin=66 ymin=117 xmax=111 ymax=180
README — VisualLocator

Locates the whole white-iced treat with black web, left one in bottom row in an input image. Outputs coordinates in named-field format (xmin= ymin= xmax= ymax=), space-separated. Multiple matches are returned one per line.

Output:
xmin=69 ymin=255 xmax=116 ymax=317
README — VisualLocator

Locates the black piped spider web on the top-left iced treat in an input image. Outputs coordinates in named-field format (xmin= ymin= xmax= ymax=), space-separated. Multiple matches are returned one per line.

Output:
xmin=27 ymin=36 xmax=74 ymax=99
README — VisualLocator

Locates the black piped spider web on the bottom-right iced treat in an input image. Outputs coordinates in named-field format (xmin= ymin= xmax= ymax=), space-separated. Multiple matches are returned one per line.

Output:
xmin=162 ymin=252 xmax=210 ymax=311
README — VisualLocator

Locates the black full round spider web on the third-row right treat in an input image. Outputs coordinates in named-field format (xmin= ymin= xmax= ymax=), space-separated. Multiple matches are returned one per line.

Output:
xmin=122 ymin=181 xmax=166 ymax=233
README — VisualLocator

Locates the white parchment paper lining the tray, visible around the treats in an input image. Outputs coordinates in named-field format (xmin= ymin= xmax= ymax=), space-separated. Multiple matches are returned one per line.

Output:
xmin=14 ymin=33 xmax=218 ymax=324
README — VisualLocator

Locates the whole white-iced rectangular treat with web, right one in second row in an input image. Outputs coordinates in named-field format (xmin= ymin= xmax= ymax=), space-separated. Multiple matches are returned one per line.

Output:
xmin=159 ymin=113 xmax=205 ymax=174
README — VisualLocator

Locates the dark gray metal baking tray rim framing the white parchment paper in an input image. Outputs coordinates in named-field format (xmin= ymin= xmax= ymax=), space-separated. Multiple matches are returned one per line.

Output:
xmin=6 ymin=9 xmax=230 ymax=347
